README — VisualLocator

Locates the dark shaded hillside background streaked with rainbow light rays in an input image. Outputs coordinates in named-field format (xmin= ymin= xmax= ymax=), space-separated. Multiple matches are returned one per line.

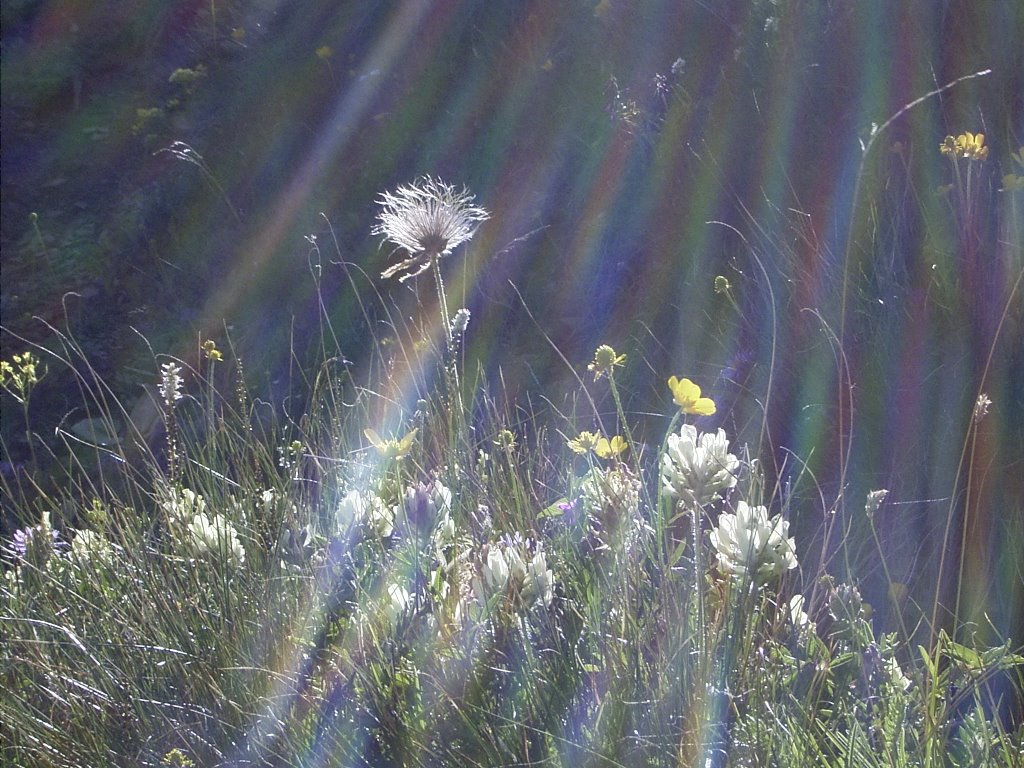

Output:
xmin=6 ymin=0 xmax=1024 ymax=641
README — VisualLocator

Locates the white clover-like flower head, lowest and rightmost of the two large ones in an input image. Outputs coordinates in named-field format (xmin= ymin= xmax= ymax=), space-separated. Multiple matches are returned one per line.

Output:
xmin=711 ymin=501 xmax=797 ymax=584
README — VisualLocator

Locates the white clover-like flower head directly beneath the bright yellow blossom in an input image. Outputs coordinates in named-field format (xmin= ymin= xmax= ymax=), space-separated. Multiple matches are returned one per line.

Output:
xmin=662 ymin=424 xmax=739 ymax=506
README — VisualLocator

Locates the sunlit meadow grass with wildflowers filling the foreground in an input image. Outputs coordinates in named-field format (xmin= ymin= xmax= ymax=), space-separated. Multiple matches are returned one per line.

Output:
xmin=0 ymin=157 xmax=1024 ymax=768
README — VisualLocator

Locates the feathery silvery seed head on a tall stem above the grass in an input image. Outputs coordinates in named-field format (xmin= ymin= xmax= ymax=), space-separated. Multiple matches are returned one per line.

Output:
xmin=371 ymin=176 xmax=490 ymax=282
